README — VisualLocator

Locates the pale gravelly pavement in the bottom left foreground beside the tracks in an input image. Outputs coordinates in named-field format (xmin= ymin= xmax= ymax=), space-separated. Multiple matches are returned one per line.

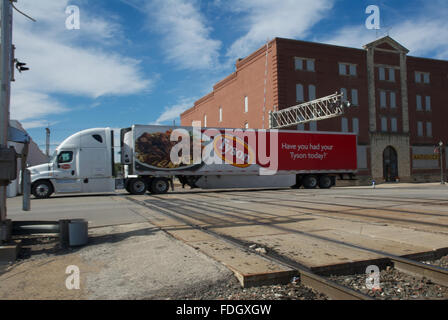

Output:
xmin=0 ymin=223 xmax=232 ymax=300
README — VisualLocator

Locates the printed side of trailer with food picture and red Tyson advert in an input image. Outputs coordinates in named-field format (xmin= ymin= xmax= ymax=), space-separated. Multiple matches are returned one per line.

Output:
xmin=134 ymin=126 xmax=357 ymax=174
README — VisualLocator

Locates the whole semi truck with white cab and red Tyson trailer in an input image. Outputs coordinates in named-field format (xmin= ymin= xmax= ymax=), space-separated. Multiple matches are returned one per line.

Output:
xmin=29 ymin=125 xmax=357 ymax=198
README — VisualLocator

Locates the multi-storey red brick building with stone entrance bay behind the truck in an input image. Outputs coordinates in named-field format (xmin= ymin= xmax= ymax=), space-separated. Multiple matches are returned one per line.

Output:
xmin=181 ymin=37 xmax=448 ymax=182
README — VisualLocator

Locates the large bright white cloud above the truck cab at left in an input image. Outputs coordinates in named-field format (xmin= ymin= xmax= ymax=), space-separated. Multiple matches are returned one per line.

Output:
xmin=11 ymin=0 xmax=152 ymax=126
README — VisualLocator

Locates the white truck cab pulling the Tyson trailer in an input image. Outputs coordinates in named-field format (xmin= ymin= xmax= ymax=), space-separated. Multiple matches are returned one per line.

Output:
xmin=28 ymin=128 xmax=115 ymax=198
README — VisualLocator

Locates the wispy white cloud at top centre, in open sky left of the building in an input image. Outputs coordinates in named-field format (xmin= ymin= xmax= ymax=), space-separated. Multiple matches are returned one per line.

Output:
xmin=145 ymin=0 xmax=221 ymax=70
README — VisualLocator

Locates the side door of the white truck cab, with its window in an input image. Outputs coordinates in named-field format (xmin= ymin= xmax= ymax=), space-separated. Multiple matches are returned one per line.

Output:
xmin=54 ymin=150 xmax=81 ymax=192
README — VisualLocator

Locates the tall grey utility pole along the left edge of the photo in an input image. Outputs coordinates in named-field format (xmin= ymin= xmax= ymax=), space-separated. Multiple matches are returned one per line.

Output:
xmin=0 ymin=0 xmax=13 ymax=242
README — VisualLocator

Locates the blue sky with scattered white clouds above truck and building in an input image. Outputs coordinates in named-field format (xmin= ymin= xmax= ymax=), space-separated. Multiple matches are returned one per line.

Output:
xmin=11 ymin=0 xmax=448 ymax=150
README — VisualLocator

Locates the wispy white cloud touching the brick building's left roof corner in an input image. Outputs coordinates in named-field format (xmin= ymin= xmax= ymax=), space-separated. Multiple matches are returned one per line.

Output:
xmin=227 ymin=0 xmax=334 ymax=60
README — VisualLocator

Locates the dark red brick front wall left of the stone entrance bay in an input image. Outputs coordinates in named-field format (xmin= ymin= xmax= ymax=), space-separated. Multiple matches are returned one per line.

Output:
xmin=277 ymin=39 xmax=369 ymax=144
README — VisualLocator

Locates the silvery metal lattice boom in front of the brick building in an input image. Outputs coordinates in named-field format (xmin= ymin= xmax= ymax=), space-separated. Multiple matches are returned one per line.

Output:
xmin=269 ymin=93 xmax=350 ymax=129
